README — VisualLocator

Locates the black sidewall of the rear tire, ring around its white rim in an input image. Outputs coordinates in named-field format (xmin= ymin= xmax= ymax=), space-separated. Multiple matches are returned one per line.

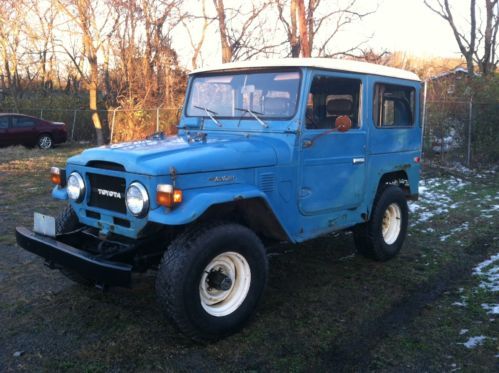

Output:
xmin=369 ymin=186 xmax=409 ymax=260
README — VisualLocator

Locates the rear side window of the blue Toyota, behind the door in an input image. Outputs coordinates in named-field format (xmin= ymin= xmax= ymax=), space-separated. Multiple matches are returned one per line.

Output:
xmin=373 ymin=83 xmax=416 ymax=128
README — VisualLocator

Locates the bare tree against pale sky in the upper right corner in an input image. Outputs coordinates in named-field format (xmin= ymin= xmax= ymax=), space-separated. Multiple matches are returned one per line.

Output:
xmin=424 ymin=0 xmax=499 ymax=76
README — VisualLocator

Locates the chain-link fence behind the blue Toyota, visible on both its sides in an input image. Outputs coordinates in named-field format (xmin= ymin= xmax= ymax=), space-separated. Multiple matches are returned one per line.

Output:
xmin=1 ymin=100 xmax=499 ymax=167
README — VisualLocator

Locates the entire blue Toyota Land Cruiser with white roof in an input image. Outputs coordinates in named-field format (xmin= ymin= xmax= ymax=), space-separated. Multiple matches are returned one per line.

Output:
xmin=16 ymin=58 xmax=422 ymax=340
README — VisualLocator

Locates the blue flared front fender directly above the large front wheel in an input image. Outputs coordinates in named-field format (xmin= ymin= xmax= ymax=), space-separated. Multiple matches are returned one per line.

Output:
xmin=148 ymin=184 xmax=269 ymax=225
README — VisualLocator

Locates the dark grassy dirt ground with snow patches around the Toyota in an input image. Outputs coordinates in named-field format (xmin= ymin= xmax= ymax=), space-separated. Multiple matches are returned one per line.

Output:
xmin=0 ymin=147 xmax=499 ymax=372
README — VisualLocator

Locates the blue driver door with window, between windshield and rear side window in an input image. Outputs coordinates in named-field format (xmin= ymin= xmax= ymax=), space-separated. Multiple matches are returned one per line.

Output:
xmin=299 ymin=72 xmax=366 ymax=215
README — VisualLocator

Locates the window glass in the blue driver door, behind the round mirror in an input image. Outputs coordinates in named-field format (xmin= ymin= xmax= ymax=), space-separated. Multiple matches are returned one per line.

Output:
xmin=305 ymin=76 xmax=361 ymax=129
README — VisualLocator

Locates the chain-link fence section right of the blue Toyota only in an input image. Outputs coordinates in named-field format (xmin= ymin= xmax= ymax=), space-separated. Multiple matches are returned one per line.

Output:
xmin=423 ymin=100 xmax=499 ymax=168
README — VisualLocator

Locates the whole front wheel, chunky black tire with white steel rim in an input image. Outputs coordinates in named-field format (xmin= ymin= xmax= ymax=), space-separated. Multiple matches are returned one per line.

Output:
xmin=156 ymin=223 xmax=268 ymax=340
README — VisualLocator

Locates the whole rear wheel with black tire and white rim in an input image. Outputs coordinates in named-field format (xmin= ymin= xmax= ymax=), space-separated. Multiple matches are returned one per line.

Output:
xmin=353 ymin=185 xmax=409 ymax=261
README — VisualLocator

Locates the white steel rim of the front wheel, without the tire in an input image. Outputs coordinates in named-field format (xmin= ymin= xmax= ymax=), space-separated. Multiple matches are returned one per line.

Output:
xmin=199 ymin=251 xmax=251 ymax=317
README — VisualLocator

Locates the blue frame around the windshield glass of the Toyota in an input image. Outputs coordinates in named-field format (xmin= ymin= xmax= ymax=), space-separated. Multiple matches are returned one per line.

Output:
xmin=183 ymin=66 xmax=304 ymax=121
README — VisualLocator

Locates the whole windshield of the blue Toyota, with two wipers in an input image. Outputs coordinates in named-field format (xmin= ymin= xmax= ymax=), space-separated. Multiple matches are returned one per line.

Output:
xmin=186 ymin=70 xmax=300 ymax=120
